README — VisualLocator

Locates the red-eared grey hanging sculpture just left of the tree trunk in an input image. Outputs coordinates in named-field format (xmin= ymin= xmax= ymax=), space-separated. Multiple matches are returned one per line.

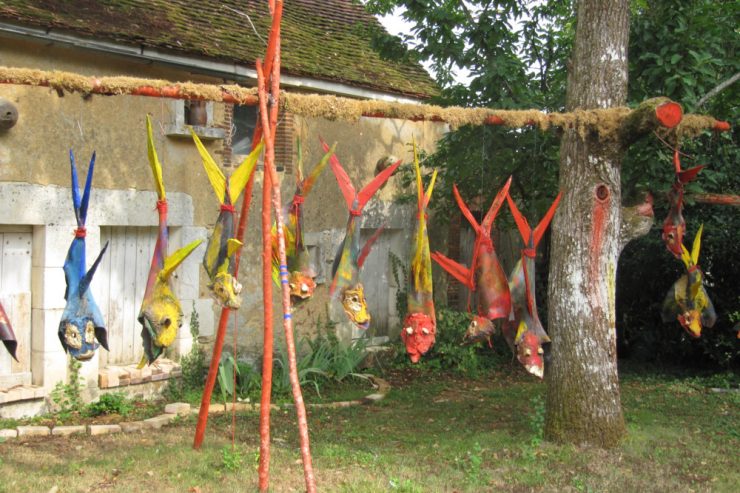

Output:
xmin=502 ymin=190 xmax=561 ymax=378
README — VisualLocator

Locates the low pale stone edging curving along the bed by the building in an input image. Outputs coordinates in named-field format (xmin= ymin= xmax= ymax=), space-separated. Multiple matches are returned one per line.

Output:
xmin=0 ymin=376 xmax=391 ymax=439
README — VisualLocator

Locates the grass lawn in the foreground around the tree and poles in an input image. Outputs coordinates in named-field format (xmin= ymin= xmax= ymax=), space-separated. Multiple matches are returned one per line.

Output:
xmin=0 ymin=366 xmax=740 ymax=493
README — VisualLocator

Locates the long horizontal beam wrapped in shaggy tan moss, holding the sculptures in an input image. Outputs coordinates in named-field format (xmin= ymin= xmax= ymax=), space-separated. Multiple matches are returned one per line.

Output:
xmin=0 ymin=67 xmax=730 ymax=136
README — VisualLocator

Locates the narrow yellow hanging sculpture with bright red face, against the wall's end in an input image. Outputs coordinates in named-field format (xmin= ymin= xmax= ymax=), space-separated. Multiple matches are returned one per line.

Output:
xmin=401 ymin=144 xmax=437 ymax=363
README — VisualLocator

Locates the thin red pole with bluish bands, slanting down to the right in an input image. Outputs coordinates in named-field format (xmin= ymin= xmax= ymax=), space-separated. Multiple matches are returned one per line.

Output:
xmin=257 ymin=54 xmax=316 ymax=493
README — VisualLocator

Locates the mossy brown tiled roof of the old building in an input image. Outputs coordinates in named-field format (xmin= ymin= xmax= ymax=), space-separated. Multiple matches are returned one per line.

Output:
xmin=0 ymin=0 xmax=437 ymax=98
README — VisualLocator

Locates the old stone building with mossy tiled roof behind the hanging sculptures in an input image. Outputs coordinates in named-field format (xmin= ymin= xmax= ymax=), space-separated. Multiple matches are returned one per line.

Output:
xmin=0 ymin=0 xmax=447 ymax=416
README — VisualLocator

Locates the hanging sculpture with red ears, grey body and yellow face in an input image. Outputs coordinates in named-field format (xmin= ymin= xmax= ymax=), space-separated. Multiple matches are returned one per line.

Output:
xmin=321 ymin=140 xmax=401 ymax=330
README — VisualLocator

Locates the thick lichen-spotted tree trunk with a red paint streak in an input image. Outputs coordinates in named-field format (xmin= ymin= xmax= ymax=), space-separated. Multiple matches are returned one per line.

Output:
xmin=545 ymin=0 xmax=629 ymax=447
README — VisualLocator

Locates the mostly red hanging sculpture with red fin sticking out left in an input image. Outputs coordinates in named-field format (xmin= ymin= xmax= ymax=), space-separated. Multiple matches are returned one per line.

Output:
xmin=432 ymin=178 xmax=511 ymax=344
